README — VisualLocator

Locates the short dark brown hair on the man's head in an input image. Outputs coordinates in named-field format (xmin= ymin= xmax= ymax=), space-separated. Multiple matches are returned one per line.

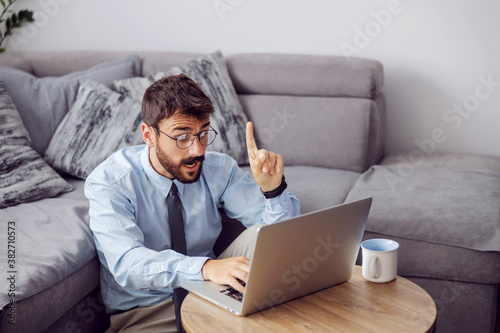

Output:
xmin=142 ymin=74 xmax=214 ymax=128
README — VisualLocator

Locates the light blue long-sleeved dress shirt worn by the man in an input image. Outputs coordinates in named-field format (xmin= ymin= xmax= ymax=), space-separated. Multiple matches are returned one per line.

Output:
xmin=85 ymin=145 xmax=300 ymax=313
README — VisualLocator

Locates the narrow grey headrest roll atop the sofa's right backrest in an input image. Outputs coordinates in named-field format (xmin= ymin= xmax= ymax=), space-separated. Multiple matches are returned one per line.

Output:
xmin=227 ymin=53 xmax=384 ymax=99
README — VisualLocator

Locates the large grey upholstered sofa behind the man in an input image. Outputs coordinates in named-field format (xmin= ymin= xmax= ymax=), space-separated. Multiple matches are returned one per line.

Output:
xmin=0 ymin=51 xmax=500 ymax=332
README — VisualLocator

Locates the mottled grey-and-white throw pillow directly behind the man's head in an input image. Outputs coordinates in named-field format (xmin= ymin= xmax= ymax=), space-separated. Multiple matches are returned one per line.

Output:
xmin=113 ymin=51 xmax=248 ymax=164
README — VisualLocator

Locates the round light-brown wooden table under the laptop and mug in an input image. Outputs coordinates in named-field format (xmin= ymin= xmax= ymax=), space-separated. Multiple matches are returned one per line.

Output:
xmin=181 ymin=266 xmax=436 ymax=333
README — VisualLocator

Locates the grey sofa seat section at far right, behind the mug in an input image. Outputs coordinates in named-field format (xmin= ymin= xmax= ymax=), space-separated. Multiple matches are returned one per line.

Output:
xmin=347 ymin=151 xmax=500 ymax=284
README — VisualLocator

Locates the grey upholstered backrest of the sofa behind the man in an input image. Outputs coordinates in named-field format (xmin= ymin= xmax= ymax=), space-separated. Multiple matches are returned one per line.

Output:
xmin=0 ymin=51 xmax=385 ymax=172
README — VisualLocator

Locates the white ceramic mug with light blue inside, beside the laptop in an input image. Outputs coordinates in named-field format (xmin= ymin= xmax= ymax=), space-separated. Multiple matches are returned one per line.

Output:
xmin=361 ymin=238 xmax=399 ymax=283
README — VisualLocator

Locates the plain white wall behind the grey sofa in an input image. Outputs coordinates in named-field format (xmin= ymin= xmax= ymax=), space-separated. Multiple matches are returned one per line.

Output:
xmin=7 ymin=0 xmax=500 ymax=156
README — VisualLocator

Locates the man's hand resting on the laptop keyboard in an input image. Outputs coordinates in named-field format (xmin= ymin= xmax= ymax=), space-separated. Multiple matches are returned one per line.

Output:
xmin=201 ymin=257 xmax=250 ymax=293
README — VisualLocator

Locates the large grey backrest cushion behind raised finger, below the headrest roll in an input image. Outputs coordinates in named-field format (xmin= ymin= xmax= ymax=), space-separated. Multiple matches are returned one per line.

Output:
xmin=240 ymin=95 xmax=383 ymax=172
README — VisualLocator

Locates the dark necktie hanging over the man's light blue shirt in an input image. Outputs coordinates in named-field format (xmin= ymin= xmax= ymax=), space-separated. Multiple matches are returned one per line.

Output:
xmin=167 ymin=182 xmax=187 ymax=332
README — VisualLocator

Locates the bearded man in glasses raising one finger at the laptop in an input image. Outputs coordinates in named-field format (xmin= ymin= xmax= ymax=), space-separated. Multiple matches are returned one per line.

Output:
xmin=85 ymin=74 xmax=300 ymax=332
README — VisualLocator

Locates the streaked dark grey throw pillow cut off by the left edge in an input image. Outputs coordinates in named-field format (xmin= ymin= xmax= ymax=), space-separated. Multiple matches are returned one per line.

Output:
xmin=0 ymin=81 xmax=72 ymax=208
